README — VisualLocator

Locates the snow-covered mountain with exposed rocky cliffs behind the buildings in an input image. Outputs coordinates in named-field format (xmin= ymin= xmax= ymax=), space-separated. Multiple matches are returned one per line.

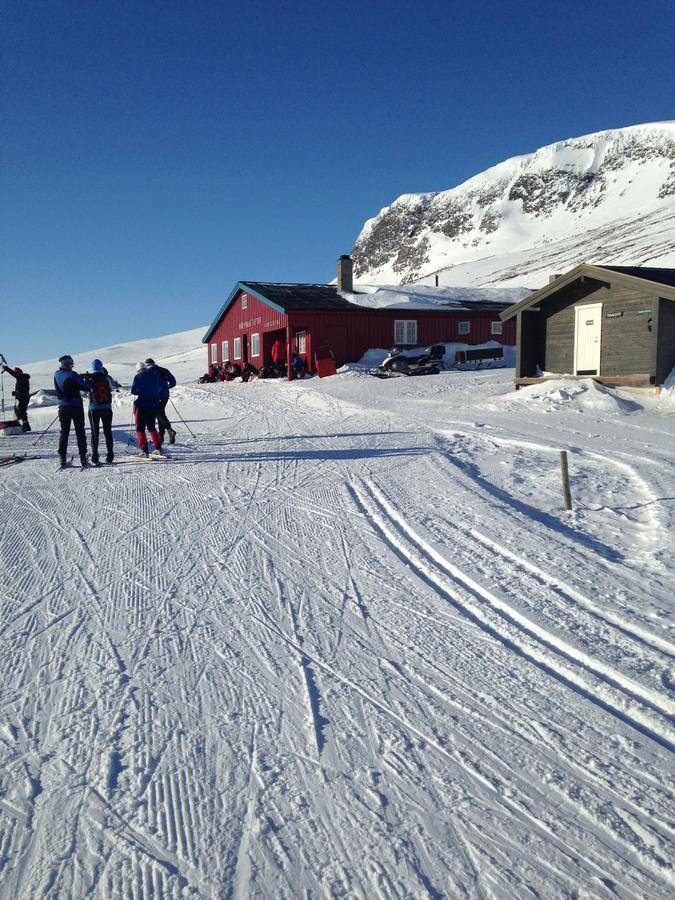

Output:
xmin=352 ymin=121 xmax=675 ymax=287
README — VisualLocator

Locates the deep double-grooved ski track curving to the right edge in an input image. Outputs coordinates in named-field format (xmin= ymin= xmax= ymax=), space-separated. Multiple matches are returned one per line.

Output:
xmin=353 ymin=484 xmax=675 ymax=752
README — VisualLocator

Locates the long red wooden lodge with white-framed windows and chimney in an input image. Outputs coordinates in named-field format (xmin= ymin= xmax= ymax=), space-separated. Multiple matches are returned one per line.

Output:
xmin=202 ymin=257 xmax=516 ymax=372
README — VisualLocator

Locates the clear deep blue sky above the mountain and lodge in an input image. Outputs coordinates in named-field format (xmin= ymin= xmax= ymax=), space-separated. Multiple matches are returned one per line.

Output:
xmin=0 ymin=0 xmax=675 ymax=362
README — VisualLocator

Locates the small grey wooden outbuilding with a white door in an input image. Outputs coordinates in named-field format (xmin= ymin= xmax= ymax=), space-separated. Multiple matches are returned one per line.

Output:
xmin=500 ymin=263 xmax=675 ymax=387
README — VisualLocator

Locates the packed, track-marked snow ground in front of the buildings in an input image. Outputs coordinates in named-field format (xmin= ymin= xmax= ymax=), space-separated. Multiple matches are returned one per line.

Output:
xmin=0 ymin=333 xmax=675 ymax=898
